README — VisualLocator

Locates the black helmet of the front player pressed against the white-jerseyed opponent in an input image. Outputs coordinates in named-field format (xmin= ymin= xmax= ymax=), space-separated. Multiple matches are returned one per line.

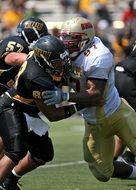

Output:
xmin=33 ymin=35 xmax=70 ymax=81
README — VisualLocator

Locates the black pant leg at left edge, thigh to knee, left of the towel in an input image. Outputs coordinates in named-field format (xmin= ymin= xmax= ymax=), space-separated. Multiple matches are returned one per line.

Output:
xmin=0 ymin=108 xmax=28 ymax=164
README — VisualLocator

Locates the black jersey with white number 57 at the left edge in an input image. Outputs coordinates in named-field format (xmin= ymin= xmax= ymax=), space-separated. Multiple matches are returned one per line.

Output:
xmin=0 ymin=36 xmax=29 ymax=94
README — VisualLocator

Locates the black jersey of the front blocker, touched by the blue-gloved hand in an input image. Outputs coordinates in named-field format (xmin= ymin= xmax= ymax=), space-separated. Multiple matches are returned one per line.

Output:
xmin=14 ymin=52 xmax=55 ymax=114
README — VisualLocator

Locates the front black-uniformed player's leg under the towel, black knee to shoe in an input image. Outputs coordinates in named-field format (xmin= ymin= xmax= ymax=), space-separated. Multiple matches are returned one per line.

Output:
xmin=0 ymin=131 xmax=54 ymax=190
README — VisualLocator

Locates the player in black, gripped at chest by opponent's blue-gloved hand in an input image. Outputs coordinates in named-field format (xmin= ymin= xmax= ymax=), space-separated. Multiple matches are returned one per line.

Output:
xmin=0 ymin=35 xmax=76 ymax=190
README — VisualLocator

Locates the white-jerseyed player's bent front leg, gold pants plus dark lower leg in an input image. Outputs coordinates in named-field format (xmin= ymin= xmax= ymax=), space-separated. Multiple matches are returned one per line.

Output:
xmin=84 ymin=108 xmax=135 ymax=181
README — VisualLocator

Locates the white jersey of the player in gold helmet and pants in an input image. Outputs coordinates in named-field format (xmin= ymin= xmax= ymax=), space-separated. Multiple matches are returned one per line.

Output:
xmin=70 ymin=37 xmax=121 ymax=124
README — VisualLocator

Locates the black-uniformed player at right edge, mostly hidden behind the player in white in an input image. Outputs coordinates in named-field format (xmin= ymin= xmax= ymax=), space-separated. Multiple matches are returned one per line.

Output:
xmin=115 ymin=41 xmax=136 ymax=164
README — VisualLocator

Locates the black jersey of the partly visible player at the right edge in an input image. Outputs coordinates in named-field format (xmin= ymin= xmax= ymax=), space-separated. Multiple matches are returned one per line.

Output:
xmin=115 ymin=56 xmax=136 ymax=111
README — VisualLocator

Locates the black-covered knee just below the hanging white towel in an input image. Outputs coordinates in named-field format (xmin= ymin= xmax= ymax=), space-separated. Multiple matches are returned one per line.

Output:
xmin=28 ymin=131 xmax=54 ymax=165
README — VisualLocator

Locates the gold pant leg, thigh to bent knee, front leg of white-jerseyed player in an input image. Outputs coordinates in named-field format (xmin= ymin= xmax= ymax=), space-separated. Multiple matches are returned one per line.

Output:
xmin=83 ymin=122 xmax=114 ymax=182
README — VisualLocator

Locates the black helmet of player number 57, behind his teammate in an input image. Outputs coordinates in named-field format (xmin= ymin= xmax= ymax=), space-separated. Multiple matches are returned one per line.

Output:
xmin=16 ymin=17 xmax=48 ymax=45
